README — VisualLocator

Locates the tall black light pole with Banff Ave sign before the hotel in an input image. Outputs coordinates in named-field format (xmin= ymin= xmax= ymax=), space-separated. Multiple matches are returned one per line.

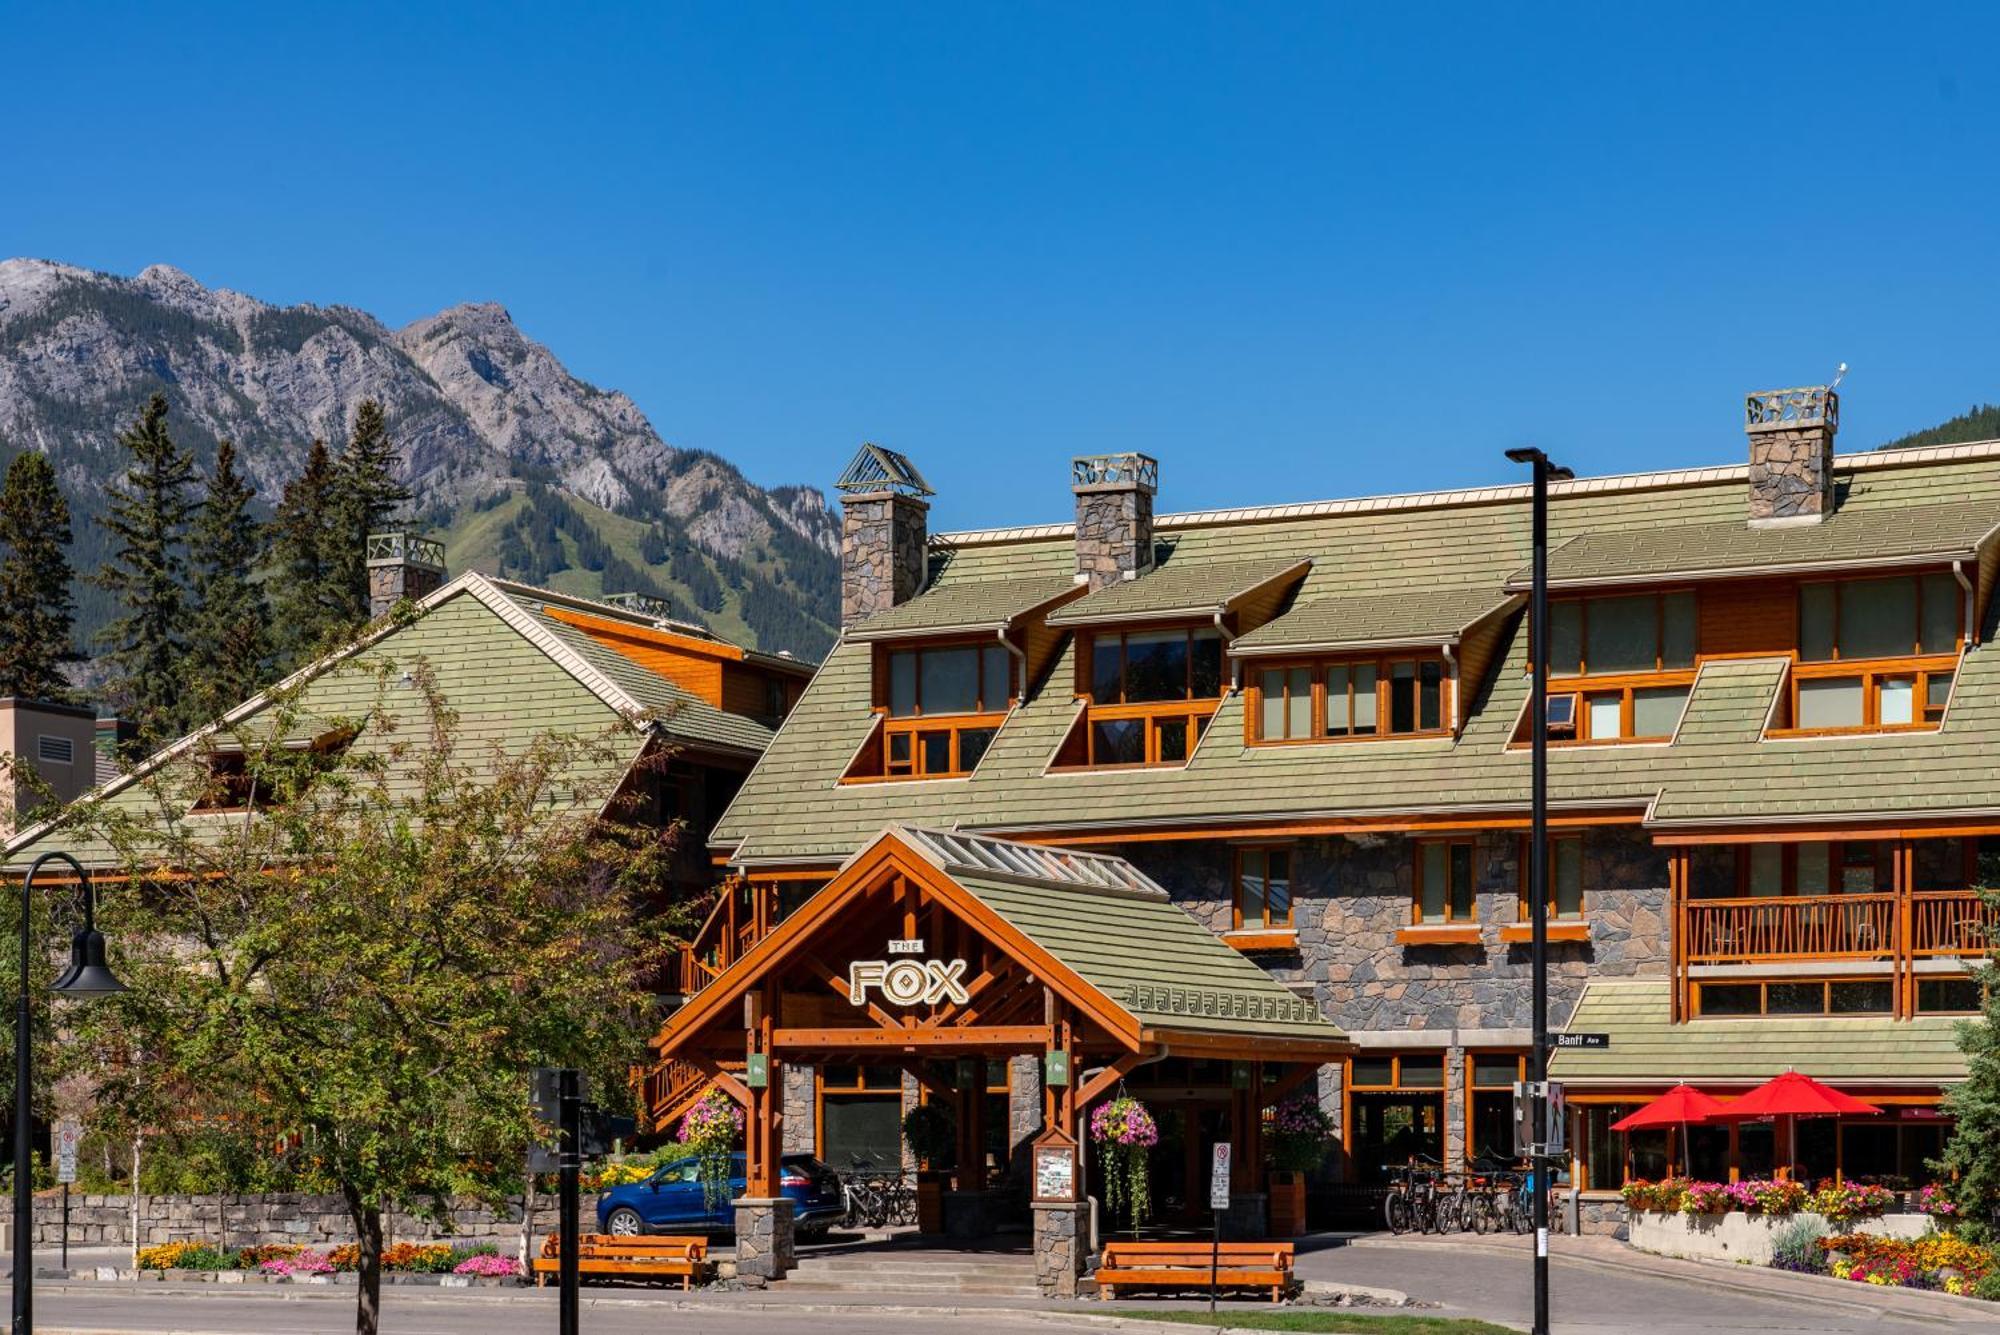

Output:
xmin=1506 ymin=446 xmax=1576 ymax=1335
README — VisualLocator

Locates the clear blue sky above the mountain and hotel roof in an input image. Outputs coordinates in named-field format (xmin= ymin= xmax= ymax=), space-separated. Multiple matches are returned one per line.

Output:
xmin=0 ymin=0 xmax=2000 ymax=528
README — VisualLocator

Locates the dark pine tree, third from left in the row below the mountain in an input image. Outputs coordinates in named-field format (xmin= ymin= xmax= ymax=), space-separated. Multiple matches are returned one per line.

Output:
xmin=182 ymin=440 xmax=270 ymax=719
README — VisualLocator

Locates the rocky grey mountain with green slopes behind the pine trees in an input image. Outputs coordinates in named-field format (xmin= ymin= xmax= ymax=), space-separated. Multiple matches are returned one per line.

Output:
xmin=0 ymin=260 xmax=838 ymax=658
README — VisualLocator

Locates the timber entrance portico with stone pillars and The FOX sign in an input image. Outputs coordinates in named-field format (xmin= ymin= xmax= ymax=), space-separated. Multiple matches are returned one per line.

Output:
xmin=646 ymin=825 xmax=1350 ymax=1293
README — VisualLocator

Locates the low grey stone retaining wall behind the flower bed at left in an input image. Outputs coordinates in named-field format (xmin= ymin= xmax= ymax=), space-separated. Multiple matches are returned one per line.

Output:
xmin=34 ymin=1191 xmax=598 ymax=1255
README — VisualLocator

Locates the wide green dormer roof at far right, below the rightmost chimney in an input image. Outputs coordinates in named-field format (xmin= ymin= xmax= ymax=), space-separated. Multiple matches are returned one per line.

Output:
xmin=1508 ymin=498 xmax=2000 ymax=590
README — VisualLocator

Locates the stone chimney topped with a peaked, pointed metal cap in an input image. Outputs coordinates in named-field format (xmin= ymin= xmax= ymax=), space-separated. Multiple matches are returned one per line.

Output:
xmin=834 ymin=446 xmax=932 ymax=626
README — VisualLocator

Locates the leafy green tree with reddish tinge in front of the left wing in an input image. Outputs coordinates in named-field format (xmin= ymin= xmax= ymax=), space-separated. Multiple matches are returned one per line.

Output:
xmin=68 ymin=656 xmax=686 ymax=1335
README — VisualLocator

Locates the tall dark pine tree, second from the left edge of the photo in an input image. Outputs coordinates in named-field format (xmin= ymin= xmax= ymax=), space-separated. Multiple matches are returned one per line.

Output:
xmin=92 ymin=394 xmax=194 ymax=745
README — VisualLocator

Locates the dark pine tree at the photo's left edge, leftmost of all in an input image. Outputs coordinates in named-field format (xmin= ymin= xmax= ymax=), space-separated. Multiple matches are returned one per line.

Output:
xmin=0 ymin=450 xmax=76 ymax=701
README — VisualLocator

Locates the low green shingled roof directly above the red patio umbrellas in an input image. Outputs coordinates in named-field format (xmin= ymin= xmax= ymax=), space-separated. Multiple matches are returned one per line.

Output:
xmin=1548 ymin=979 xmax=1966 ymax=1087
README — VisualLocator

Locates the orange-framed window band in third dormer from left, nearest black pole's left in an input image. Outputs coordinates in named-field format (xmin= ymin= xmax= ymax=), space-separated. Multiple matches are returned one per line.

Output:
xmin=1248 ymin=656 xmax=1452 ymax=743
